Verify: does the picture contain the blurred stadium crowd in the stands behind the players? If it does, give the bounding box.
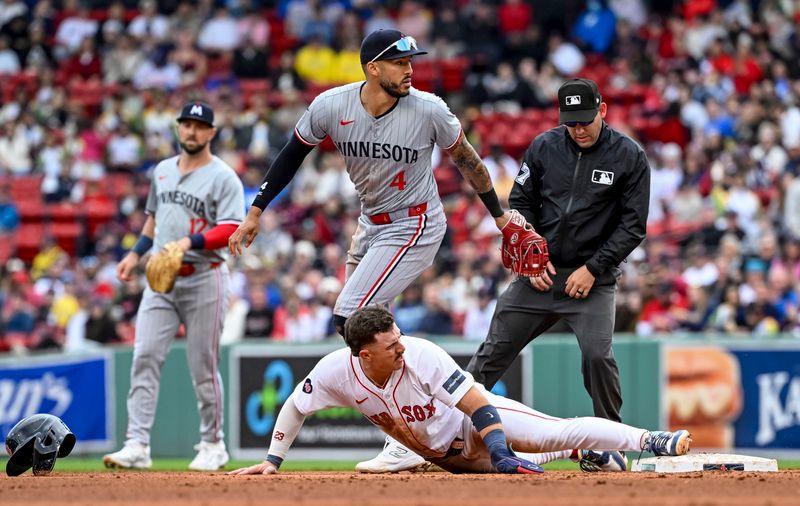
[0,0,800,352]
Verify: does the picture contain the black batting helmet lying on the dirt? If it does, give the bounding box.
[6,414,75,476]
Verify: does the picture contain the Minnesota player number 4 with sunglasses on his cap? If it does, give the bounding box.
[229,30,508,472]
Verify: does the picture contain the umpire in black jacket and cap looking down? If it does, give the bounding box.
[467,79,650,421]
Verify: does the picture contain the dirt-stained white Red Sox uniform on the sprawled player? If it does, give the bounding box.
[276,336,647,472]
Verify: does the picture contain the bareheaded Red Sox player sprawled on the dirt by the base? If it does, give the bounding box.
[229,306,692,474]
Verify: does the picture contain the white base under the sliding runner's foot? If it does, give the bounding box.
[631,453,778,473]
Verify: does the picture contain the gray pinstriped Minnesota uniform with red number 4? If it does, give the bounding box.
[295,82,461,317]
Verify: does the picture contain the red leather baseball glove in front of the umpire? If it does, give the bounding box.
[501,209,550,276]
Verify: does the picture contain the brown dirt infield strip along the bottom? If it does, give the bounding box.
[0,470,800,506]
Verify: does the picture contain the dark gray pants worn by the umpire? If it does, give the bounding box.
[467,267,622,422]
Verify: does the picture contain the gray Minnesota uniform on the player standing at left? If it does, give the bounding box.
[127,156,244,444]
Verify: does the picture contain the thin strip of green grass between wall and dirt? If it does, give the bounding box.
[0,457,800,472]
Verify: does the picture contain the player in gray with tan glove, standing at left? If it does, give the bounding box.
[103,102,244,471]
